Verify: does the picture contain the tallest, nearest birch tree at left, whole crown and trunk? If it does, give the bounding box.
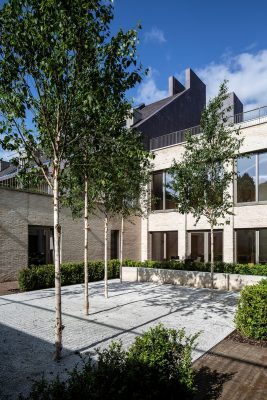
[0,0,122,360]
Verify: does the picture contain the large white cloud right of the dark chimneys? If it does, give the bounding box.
[196,50,267,109]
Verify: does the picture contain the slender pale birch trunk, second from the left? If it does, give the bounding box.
[84,176,89,315]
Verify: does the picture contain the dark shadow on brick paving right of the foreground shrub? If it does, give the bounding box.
[193,366,236,400]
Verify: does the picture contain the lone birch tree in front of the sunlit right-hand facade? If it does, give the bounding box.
[169,82,242,289]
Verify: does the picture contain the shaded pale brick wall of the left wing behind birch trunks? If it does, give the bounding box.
[0,188,141,282]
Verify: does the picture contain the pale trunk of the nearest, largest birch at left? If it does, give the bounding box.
[53,168,63,361]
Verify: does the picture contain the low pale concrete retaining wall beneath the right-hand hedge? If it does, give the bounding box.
[122,267,267,291]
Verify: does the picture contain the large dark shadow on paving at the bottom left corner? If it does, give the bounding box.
[0,324,86,400]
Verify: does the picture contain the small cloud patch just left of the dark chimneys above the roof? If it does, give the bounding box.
[134,68,168,104]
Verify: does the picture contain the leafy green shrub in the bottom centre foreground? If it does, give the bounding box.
[22,324,197,400]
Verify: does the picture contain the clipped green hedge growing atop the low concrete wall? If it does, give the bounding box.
[123,260,267,276]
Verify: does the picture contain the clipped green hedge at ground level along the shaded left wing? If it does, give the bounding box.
[18,260,120,291]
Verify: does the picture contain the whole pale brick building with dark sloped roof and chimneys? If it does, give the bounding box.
[0,69,267,281]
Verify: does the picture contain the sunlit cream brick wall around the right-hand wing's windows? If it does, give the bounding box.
[144,120,267,262]
